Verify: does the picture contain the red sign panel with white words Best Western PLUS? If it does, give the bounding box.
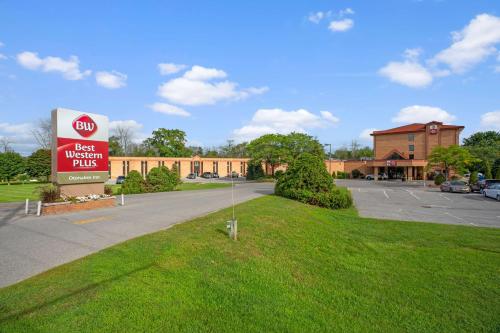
[57,138,108,172]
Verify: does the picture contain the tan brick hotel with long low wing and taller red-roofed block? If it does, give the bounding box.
[109,121,464,180]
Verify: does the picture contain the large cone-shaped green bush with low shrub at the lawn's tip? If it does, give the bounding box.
[275,153,352,209]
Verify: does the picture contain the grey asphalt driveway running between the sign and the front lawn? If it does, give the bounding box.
[0,183,274,287]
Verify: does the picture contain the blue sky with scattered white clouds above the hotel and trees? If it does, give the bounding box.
[0,0,500,153]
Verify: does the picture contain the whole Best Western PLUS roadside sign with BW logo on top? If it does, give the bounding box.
[52,108,108,184]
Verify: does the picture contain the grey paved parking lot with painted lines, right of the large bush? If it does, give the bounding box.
[337,180,500,228]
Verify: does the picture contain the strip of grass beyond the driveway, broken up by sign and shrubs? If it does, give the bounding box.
[0,183,231,202]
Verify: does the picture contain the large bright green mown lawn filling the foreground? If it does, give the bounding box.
[0,196,500,332]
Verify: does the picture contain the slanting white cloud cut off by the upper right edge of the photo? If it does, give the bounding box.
[431,14,500,73]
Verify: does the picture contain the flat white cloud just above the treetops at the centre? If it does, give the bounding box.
[233,109,339,141]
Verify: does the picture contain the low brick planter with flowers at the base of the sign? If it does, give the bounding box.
[42,194,116,215]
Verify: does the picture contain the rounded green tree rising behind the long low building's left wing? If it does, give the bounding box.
[144,128,191,157]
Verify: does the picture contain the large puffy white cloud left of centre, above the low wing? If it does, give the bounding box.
[158,66,268,105]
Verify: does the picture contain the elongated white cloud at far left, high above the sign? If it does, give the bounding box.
[17,52,91,80]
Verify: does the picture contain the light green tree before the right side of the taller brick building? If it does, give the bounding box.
[428,145,477,179]
